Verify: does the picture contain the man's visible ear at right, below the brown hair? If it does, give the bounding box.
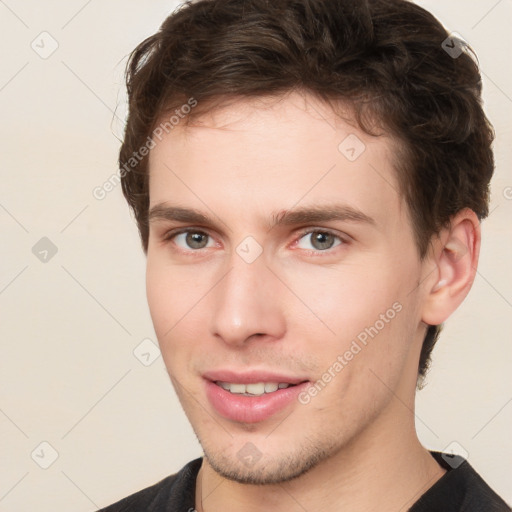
[422,208,481,325]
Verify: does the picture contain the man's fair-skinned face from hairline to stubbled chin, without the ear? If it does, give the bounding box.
[147,94,425,483]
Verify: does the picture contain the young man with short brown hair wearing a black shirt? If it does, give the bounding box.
[99,0,510,512]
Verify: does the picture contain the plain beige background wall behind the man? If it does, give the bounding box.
[0,0,512,512]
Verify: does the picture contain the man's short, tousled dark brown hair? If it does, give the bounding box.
[119,0,494,377]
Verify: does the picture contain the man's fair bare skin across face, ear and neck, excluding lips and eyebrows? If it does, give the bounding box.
[147,92,480,512]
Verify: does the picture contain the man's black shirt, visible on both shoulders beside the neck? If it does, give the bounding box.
[99,452,511,512]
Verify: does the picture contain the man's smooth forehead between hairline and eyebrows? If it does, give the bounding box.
[149,93,402,230]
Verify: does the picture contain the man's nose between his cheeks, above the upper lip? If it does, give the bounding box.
[211,252,285,347]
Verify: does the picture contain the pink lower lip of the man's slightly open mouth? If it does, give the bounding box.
[205,380,309,423]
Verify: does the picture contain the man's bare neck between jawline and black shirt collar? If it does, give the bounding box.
[196,400,445,512]
